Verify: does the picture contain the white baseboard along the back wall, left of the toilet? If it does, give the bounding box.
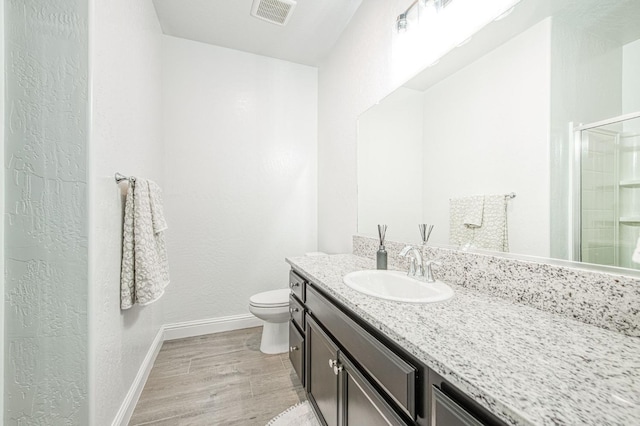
[164,314,262,340]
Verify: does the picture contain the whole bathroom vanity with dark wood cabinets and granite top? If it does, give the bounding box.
[287,255,640,426]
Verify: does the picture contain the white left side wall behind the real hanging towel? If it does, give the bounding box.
[89,0,165,425]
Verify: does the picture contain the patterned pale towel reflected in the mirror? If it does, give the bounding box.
[449,194,509,252]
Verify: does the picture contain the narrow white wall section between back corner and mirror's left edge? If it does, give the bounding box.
[318,0,404,253]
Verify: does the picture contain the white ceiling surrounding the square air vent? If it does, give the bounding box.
[153,0,362,66]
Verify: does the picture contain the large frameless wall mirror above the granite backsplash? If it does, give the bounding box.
[358,0,640,269]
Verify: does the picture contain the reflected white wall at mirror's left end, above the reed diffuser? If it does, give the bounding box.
[357,87,424,241]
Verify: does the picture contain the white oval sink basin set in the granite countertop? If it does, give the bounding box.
[342,270,453,303]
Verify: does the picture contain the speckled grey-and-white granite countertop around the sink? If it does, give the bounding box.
[287,254,640,426]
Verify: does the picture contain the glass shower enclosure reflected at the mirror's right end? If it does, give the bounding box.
[574,112,640,269]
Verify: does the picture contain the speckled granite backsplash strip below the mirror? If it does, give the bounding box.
[353,235,640,338]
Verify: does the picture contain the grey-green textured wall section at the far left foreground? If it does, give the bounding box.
[4,0,88,424]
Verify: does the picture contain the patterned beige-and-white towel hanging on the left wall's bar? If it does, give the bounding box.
[120,179,169,309]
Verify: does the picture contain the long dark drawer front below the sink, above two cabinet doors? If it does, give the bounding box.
[306,286,416,419]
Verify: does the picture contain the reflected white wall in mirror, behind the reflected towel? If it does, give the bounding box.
[423,19,551,257]
